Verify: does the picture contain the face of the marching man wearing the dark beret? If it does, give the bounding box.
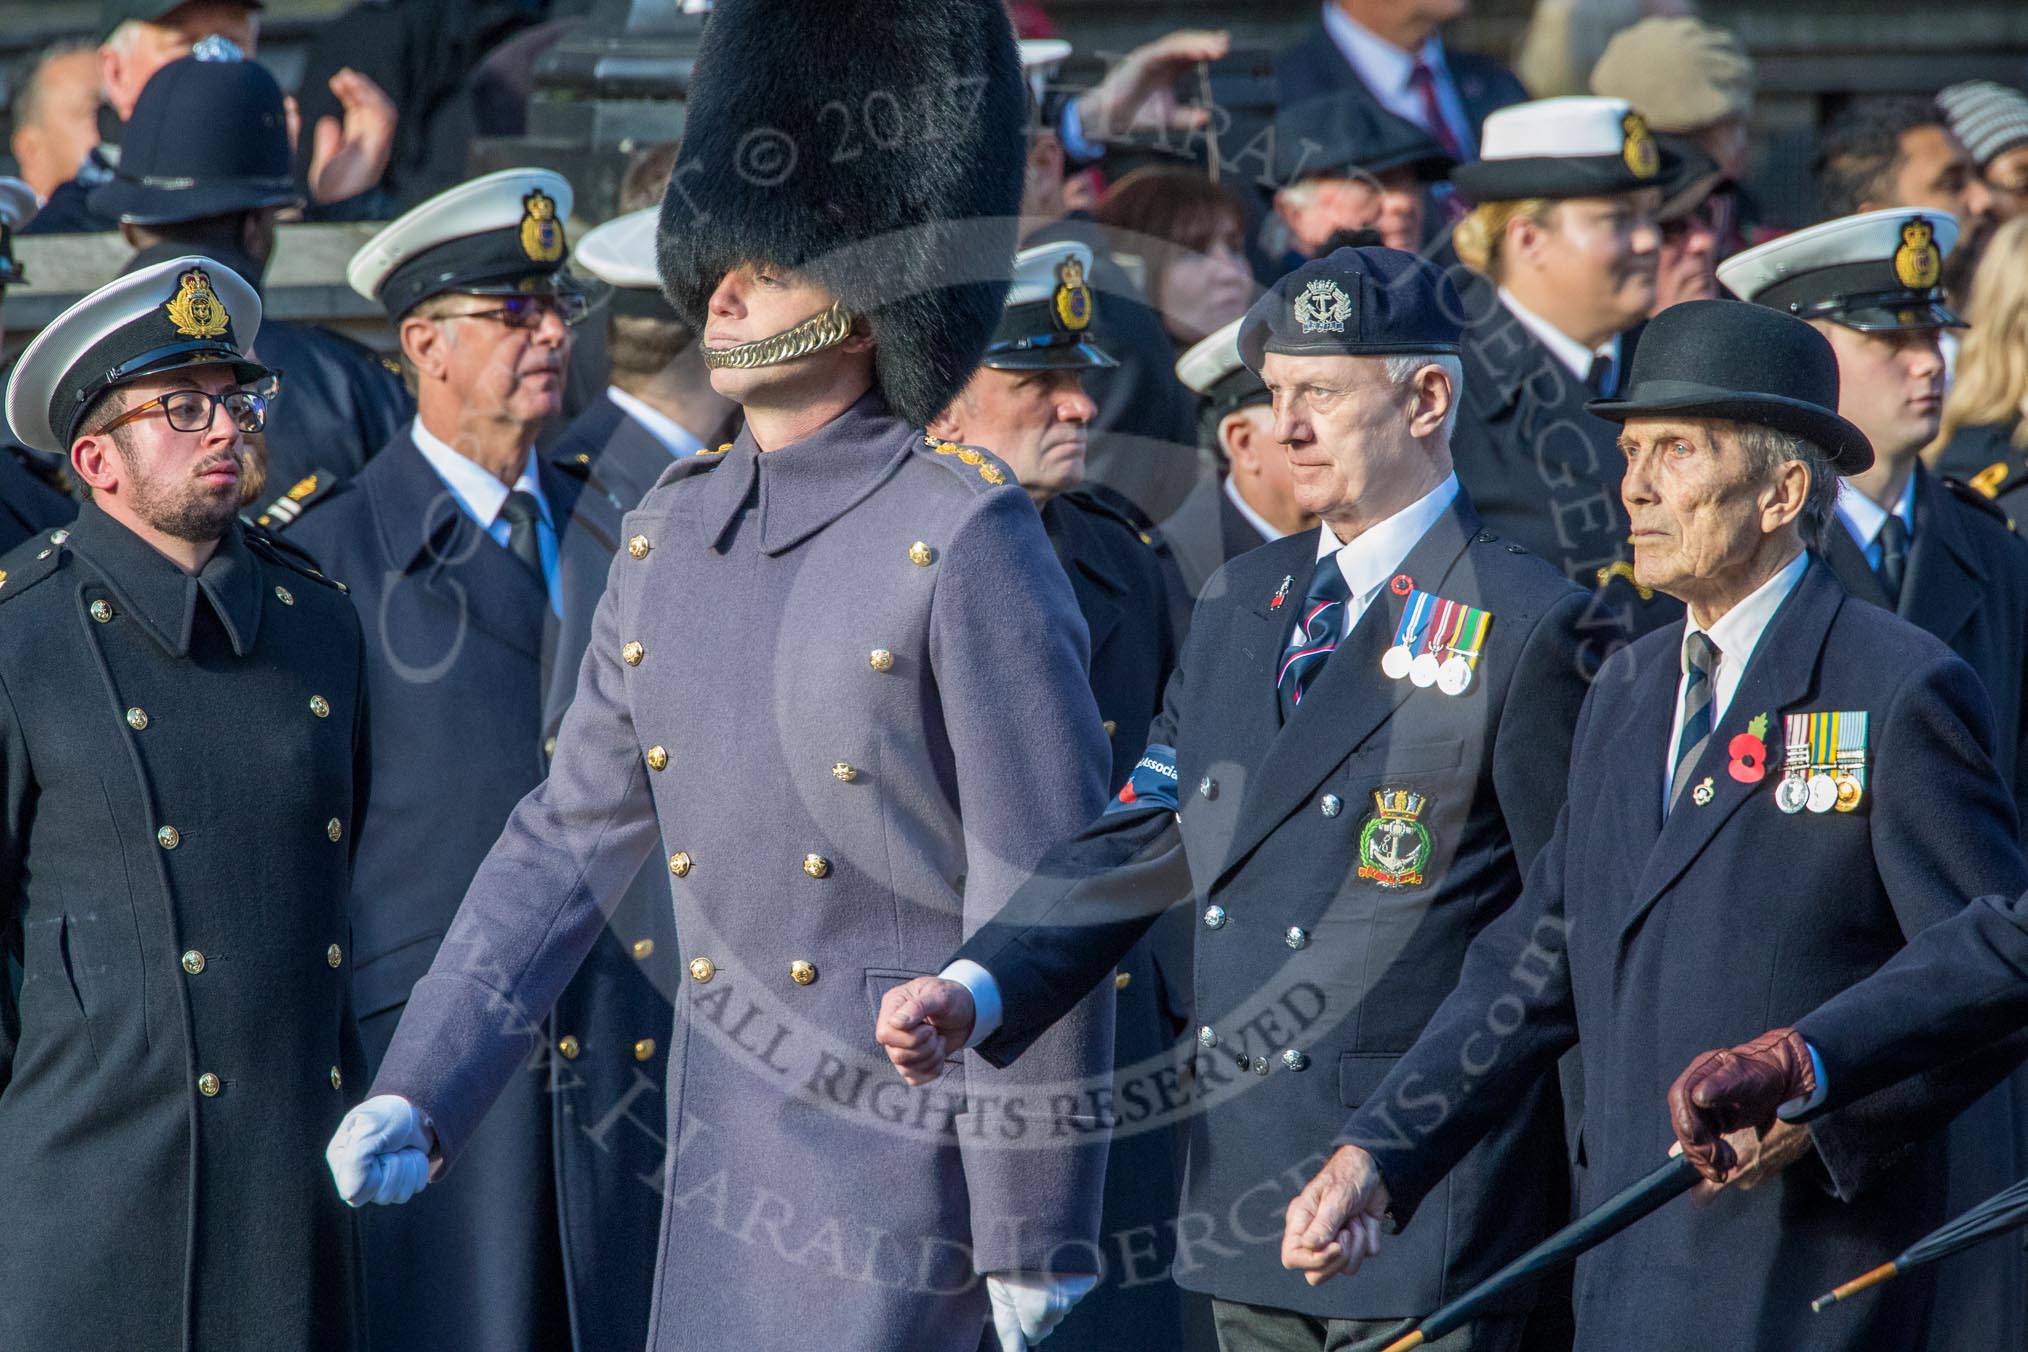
[1261,353,1442,517]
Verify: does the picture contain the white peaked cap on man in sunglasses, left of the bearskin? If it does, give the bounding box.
[345,168,574,318]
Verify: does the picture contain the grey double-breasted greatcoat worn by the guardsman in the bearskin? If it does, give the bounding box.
[375,393,1113,1352]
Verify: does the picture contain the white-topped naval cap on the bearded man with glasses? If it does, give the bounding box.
[6,253,268,456]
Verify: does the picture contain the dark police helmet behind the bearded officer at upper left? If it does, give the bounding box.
[89,39,302,225]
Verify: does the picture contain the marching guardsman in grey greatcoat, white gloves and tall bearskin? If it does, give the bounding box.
[327,0,1115,1352]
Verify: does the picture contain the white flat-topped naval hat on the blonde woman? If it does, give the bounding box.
[1450,93,1665,203]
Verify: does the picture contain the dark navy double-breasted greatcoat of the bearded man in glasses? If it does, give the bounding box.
[0,505,367,1352]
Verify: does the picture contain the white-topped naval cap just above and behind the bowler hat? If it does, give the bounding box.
[1718,207,1963,332]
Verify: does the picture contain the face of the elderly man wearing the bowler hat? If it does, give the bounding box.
[1620,418,1809,606]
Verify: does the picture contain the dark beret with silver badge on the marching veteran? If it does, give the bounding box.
[1239,245,1464,373]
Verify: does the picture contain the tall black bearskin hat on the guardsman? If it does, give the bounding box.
[657,0,1028,424]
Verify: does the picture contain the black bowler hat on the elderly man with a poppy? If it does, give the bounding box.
[1584,300,1874,474]
